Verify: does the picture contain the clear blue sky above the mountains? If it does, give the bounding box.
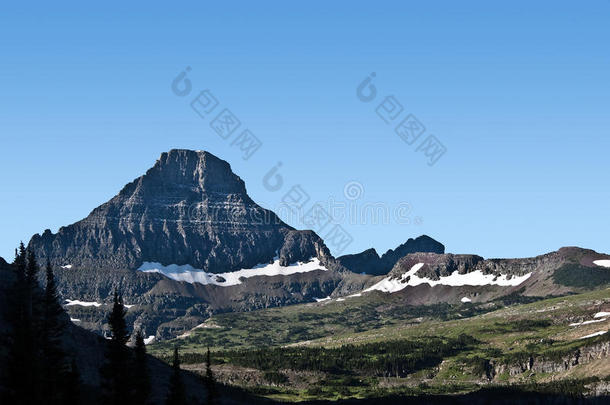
[0,1,610,259]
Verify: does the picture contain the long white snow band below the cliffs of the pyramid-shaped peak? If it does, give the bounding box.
[138,258,328,287]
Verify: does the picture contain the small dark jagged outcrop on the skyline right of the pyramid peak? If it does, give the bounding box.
[337,235,445,276]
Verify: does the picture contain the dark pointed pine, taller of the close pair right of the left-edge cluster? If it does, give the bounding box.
[100,291,131,405]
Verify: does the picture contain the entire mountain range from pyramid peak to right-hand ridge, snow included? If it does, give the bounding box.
[15,149,608,342]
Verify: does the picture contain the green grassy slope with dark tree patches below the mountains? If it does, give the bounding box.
[150,289,610,401]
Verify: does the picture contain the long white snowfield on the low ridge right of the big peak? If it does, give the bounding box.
[364,263,532,293]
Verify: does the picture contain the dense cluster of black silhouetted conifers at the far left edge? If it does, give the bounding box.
[3,243,80,405]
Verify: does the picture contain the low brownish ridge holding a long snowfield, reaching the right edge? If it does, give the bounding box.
[356,243,610,305]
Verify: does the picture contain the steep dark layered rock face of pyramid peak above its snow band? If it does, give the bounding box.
[29,149,331,272]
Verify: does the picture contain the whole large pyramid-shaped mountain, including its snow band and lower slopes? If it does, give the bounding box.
[21,149,356,338]
